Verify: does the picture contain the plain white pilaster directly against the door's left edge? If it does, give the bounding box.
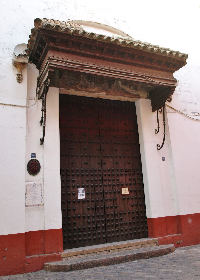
[44,88,62,230]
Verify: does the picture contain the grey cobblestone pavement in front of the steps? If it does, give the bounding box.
[0,245,200,280]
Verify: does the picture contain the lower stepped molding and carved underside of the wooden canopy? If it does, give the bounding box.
[37,54,177,107]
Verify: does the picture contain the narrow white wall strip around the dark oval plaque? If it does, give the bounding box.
[25,64,45,232]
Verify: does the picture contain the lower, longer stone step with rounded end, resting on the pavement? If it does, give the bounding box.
[44,244,175,272]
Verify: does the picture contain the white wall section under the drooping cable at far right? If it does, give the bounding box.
[167,112,200,215]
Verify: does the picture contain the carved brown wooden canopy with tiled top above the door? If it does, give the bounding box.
[27,19,187,111]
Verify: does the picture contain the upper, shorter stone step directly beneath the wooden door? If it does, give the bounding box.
[61,238,158,258]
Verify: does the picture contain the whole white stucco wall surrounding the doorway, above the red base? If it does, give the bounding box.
[0,0,200,234]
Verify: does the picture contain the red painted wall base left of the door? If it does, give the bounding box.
[0,229,63,276]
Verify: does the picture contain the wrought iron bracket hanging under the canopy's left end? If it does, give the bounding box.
[40,79,50,145]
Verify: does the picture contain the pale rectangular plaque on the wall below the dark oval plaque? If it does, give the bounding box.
[25,182,43,206]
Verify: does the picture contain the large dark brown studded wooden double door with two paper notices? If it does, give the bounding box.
[60,95,148,248]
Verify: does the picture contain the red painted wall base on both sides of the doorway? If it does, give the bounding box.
[0,213,200,275]
